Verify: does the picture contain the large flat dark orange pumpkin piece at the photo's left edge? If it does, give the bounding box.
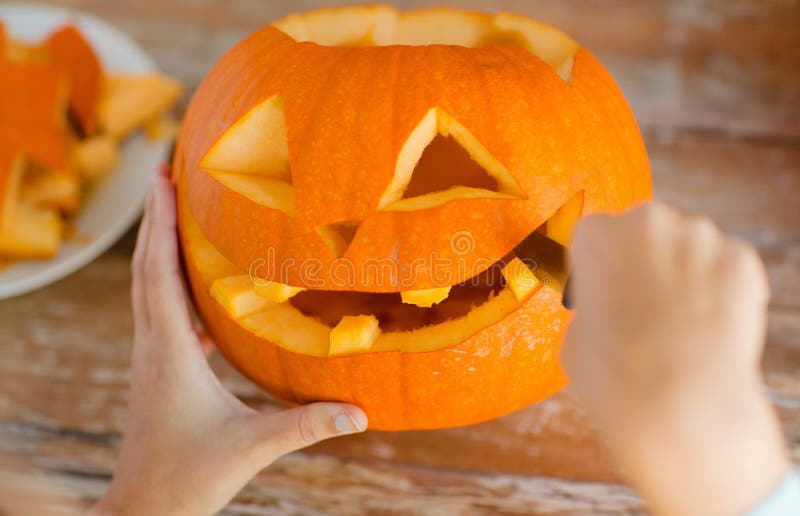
[0,62,68,169]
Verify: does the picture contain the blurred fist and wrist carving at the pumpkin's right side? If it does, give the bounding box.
[562,204,787,516]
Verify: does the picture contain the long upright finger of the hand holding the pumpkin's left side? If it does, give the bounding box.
[144,176,193,341]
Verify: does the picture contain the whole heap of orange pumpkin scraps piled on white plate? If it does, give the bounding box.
[0,23,182,263]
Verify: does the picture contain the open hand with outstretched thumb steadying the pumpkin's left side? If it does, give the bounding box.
[93,169,367,515]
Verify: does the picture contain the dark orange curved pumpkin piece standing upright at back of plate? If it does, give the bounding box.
[45,25,103,135]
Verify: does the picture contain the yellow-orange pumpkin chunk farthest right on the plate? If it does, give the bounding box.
[97,74,183,139]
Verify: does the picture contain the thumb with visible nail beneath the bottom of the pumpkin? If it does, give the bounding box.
[250,403,367,460]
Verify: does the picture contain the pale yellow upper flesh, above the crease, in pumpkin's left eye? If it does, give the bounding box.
[200,95,291,182]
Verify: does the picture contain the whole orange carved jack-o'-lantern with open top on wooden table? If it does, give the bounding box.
[175,7,651,429]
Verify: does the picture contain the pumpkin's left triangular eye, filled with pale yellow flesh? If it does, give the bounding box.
[200,95,294,215]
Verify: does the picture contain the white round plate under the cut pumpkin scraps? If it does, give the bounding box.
[0,4,169,299]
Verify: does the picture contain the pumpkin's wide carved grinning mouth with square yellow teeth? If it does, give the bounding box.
[180,186,583,356]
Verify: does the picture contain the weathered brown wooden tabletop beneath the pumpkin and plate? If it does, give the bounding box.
[0,0,800,515]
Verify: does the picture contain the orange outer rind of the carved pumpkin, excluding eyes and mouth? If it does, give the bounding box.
[173,6,652,430]
